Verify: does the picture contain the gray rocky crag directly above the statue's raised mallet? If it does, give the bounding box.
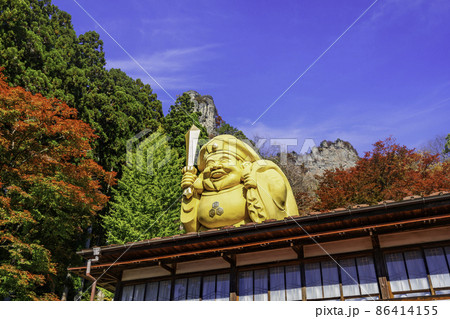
[186,90,217,135]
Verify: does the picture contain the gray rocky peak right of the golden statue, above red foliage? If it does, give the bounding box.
[297,139,359,175]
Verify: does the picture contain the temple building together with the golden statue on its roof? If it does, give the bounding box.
[71,131,450,301]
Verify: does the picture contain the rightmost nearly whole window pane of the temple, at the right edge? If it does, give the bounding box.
[425,247,450,288]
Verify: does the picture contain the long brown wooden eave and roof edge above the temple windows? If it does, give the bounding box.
[69,193,450,290]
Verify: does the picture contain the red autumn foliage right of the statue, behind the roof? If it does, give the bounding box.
[315,138,450,210]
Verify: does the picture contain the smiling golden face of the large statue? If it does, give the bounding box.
[203,153,242,191]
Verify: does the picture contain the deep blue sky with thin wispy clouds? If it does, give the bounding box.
[53,0,450,155]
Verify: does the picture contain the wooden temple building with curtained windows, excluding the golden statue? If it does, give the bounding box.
[70,192,450,301]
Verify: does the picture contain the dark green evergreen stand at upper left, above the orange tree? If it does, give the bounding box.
[0,0,163,176]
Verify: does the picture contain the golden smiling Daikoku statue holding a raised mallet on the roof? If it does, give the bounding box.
[181,126,298,232]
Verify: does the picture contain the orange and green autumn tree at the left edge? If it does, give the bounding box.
[0,73,114,300]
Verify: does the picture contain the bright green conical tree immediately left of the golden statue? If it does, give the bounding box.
[103,129,183,244]
